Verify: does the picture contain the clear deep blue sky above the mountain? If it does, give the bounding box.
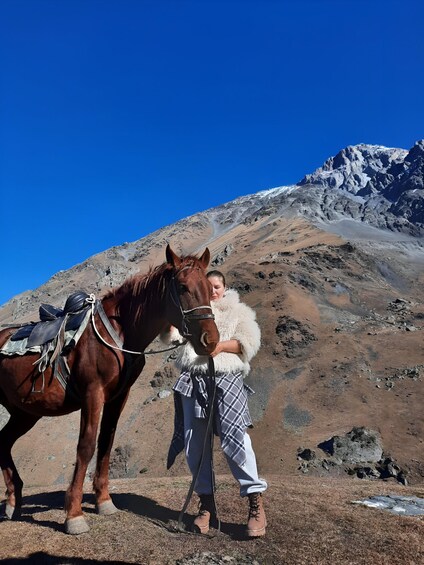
[0,0,424,304]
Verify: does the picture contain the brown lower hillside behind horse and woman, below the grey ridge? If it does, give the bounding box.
[3,219,424,485]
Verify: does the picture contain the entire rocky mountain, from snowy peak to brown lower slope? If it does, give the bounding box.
[0,141,424,494]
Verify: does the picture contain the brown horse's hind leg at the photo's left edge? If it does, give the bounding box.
[0,410,40,520]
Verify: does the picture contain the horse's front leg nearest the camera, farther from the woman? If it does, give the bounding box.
[65,391,103,534]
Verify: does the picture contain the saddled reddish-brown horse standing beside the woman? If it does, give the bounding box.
[0,245,219,534]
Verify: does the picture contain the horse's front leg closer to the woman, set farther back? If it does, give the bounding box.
[93,391,129,515]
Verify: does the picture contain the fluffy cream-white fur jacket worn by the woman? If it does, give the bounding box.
[162,289,261,375]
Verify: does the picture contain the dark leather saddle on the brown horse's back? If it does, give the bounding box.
[10,291,90,347]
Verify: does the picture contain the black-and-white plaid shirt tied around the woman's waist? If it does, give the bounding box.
[167,371,254,469]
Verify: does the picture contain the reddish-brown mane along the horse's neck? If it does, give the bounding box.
[104,255,198,322]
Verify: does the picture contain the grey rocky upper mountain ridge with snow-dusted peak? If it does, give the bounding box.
[0,140,424,322]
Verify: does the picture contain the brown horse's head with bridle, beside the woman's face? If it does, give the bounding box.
[166,245,219,355]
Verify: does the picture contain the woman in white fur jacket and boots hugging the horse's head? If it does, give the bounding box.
[167,271,267,537]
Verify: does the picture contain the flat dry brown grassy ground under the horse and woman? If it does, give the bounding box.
[0,476,424,565]
